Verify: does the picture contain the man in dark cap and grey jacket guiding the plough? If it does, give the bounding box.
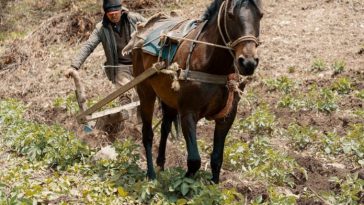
[66,0,145,104]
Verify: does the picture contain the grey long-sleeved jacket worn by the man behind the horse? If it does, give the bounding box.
[71,10,145,70]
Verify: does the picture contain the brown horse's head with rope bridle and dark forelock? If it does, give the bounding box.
[219,0,263,75]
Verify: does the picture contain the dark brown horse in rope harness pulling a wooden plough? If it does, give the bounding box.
[133,0,263,183]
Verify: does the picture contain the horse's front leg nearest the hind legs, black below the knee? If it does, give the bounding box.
[181,112,201,177]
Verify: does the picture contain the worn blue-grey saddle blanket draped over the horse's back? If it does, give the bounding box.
[143,19,197,63]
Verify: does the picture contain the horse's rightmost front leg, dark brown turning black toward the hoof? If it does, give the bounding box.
[210,97,237,184]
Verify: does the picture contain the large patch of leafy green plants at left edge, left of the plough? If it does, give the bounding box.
[0,100,90,169]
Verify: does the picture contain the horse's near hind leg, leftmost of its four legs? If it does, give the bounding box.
[137,84,156,180]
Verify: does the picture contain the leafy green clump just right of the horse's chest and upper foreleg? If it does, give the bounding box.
[239,105,276,134]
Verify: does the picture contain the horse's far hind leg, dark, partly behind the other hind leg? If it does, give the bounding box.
[157,102,177,170]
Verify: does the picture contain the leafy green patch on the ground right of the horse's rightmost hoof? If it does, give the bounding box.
[224,138,305,186]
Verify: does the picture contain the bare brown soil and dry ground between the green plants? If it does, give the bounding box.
[0,0,364,204]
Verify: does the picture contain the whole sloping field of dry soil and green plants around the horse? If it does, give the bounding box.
[0,0,364,205]
